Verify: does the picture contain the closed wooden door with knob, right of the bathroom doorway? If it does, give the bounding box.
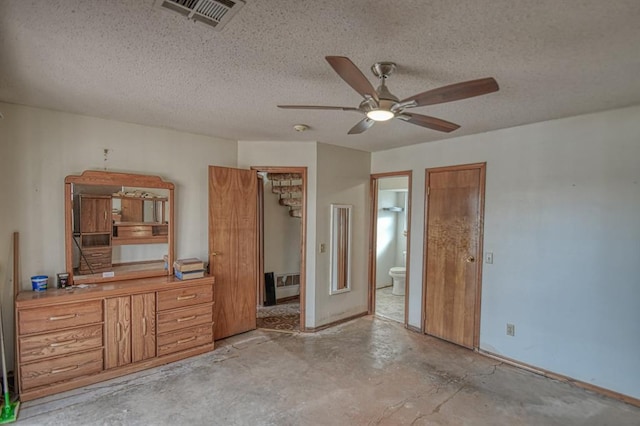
[424,163,485,348]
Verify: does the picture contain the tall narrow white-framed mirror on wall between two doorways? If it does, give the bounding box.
[329,204,353,294]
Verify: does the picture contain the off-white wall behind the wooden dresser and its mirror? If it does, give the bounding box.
[0,103,236,370]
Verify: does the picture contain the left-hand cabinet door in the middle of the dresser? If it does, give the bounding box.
[104,296,131,369]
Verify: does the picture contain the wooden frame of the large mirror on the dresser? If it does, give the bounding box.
[64,170,175,284]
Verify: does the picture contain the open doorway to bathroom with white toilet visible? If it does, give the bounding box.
[369,171,411,325]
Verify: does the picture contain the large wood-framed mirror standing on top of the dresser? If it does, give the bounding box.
[65,171,174,284]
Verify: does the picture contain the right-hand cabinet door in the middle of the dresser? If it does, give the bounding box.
[131,293,156,362]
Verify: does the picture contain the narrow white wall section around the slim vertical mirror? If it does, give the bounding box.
[315,143,371,326]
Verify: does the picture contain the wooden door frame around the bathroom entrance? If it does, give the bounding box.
[367,170,413,327]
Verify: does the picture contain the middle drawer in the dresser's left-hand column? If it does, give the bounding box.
[20,324,102,362]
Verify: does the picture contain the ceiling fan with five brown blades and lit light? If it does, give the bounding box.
[278,56,499,135]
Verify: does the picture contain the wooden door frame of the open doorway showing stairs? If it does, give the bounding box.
[251,166,308,331]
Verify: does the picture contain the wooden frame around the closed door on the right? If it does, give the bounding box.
[420,162,487,351]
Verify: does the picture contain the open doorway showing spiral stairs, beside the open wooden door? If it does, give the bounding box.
[253,167,306,332]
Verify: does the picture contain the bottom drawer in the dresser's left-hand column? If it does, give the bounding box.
[20,349,102,390]
